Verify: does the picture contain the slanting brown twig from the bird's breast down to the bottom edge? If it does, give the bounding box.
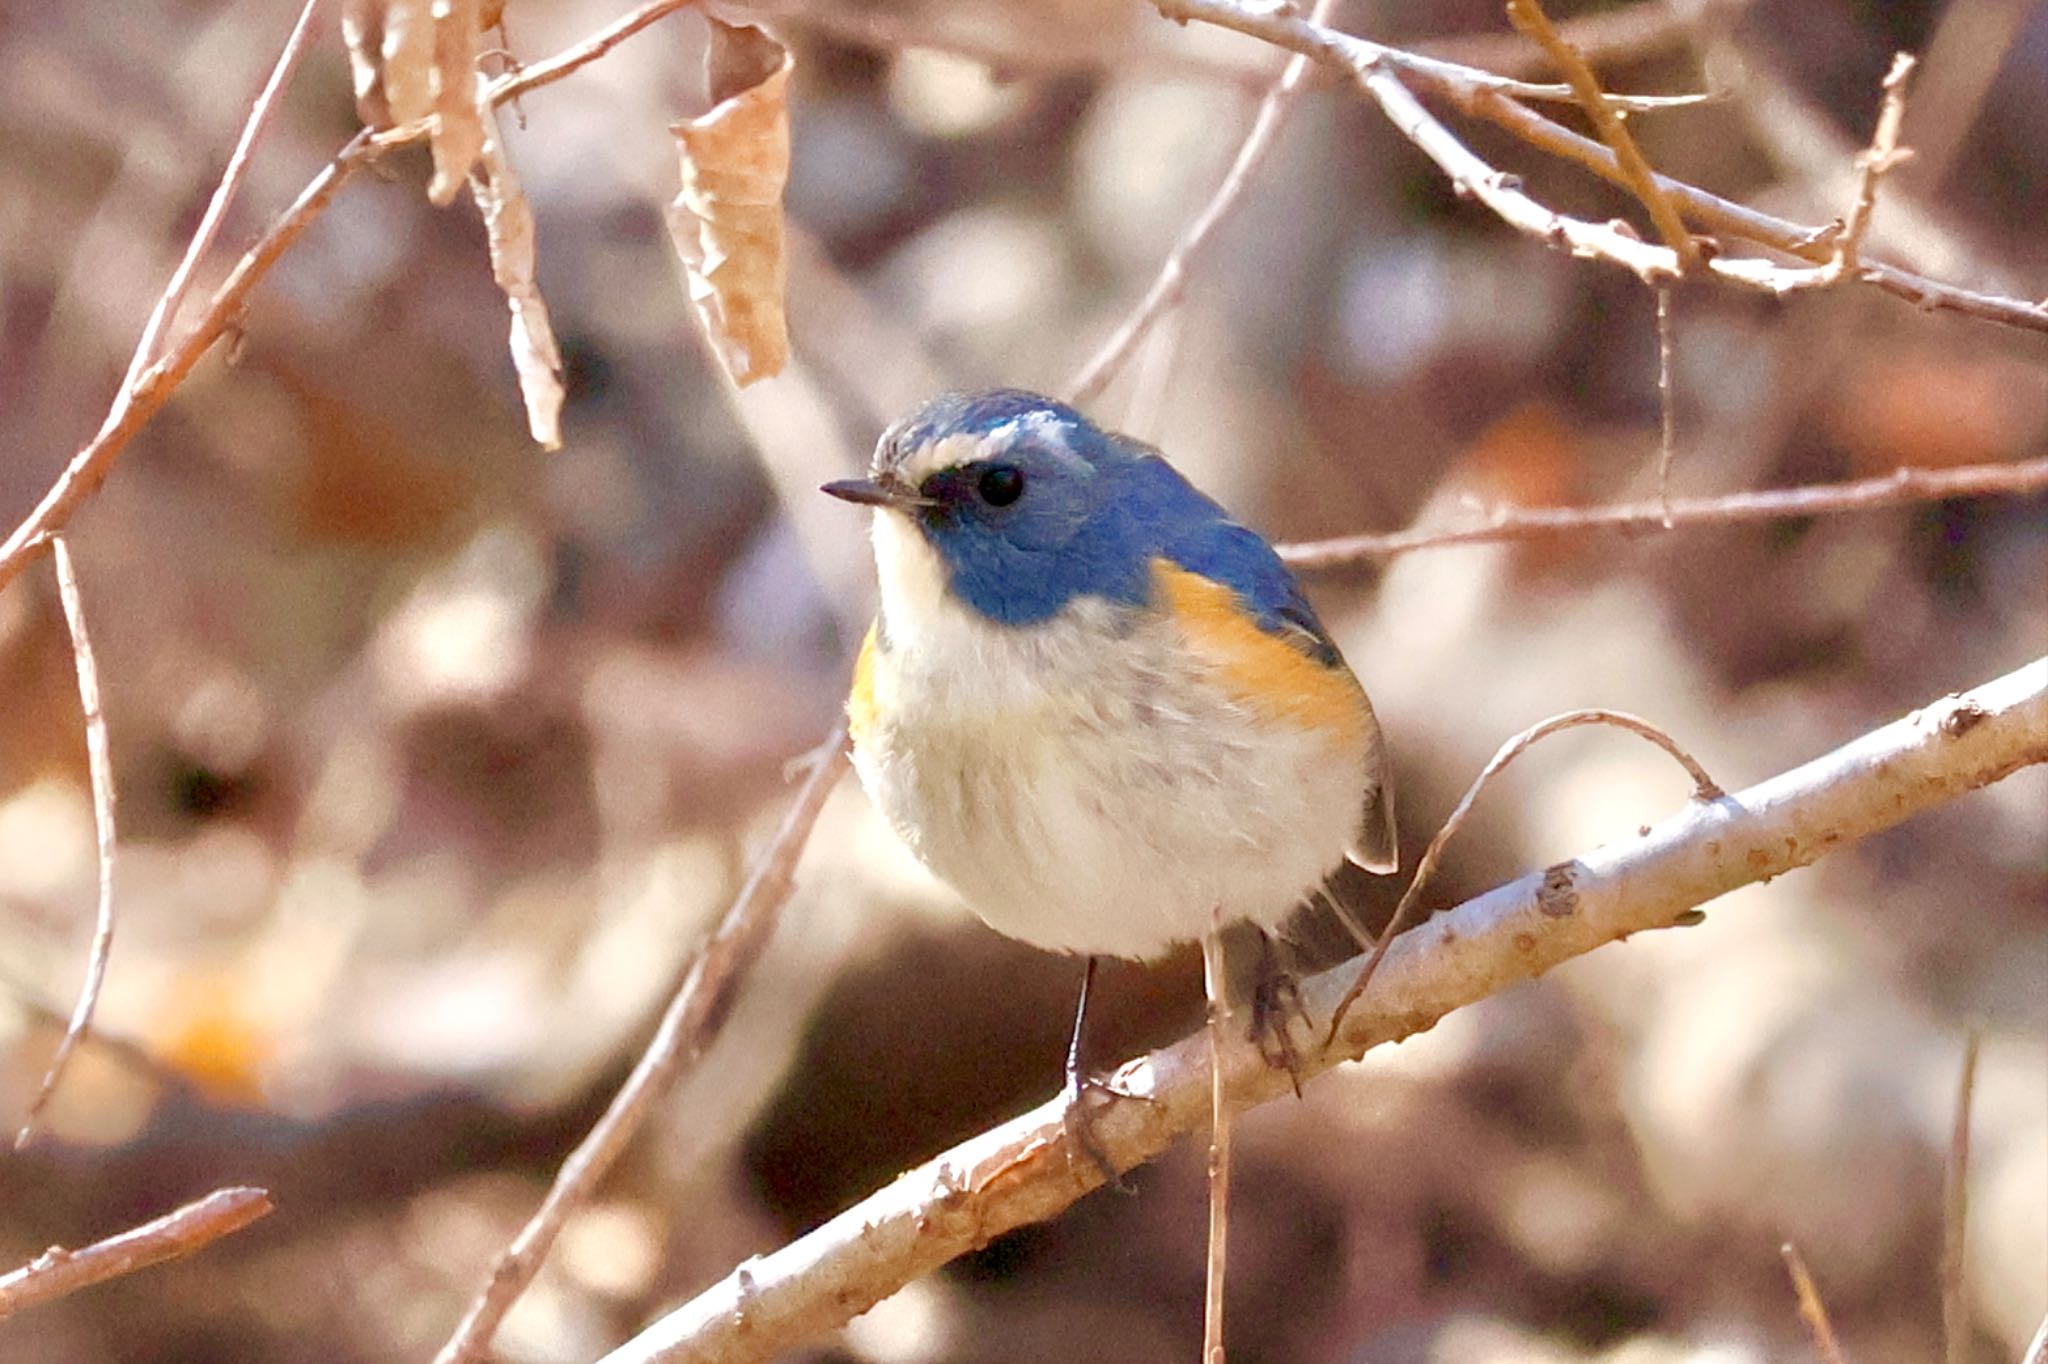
[434,721,846,1364]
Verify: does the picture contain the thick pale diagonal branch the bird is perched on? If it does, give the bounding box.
[606,659,2048,1364]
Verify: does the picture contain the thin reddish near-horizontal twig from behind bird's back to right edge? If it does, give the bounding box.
[1278,457,2048,571]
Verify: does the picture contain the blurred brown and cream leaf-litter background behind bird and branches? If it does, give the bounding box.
[0,0,2048,1364]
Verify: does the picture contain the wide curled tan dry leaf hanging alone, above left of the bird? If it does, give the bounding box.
[668,18,791,385]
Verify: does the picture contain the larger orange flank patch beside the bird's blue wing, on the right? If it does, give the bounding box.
[1153,559,1368,743]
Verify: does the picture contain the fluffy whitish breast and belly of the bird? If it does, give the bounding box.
[854,598,1366,956]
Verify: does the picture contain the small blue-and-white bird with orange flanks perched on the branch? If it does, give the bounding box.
[823,389,1399,1138]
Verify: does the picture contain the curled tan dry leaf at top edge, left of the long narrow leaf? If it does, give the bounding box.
[342,0,502,205]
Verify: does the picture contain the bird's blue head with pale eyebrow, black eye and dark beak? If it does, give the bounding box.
[825,389,1228,625]
